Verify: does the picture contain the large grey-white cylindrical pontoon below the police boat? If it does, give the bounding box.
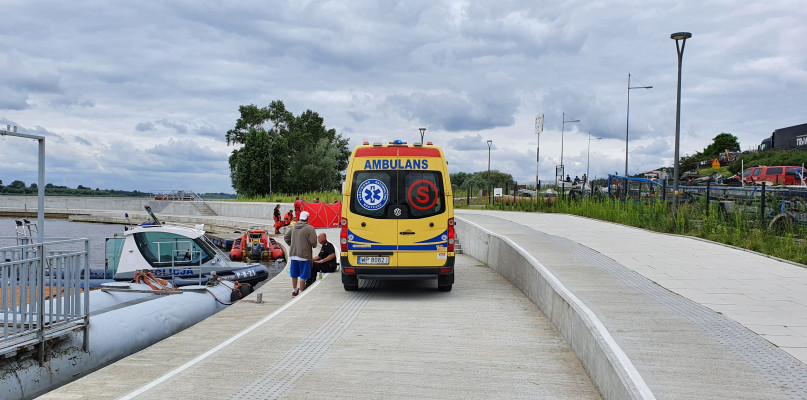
[0,283,233,399]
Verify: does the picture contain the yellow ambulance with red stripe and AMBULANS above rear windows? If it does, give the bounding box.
[339,140,455,292]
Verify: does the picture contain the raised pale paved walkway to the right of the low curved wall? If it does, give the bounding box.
[456,210,807,399]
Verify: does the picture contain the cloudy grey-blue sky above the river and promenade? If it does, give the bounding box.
[0,0,807,193]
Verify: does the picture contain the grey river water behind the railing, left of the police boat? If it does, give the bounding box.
[0,215,123,268]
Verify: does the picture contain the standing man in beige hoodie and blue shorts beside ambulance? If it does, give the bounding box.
[283,211,317,297]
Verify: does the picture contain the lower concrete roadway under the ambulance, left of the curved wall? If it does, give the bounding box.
[41,250,600,400]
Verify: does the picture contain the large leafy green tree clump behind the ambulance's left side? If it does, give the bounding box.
[226,100,350,196]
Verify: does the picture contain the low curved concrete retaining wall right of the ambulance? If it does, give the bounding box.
[457,217,655,400]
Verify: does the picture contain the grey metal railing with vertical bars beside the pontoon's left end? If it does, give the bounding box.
[0,237,90,361]
